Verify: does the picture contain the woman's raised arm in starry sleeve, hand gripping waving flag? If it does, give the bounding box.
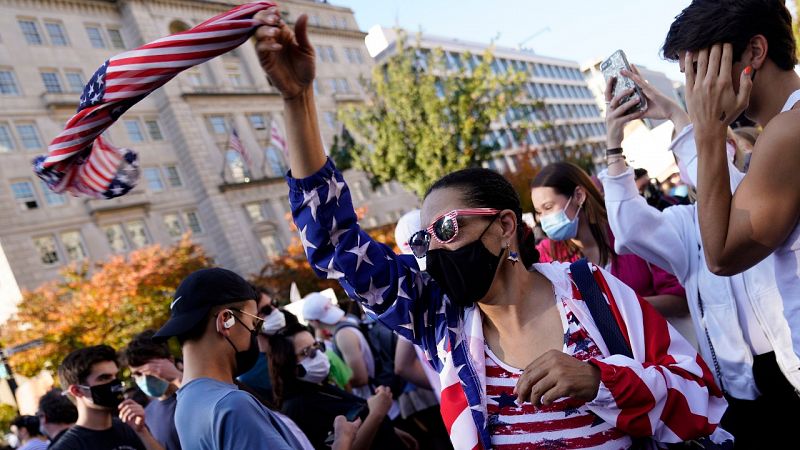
[255,8,446,353]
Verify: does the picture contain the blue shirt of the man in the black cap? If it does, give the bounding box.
[175,378,302,450]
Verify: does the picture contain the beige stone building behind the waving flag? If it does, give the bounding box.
[0,0,418,310]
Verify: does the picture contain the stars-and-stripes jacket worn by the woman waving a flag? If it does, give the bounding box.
[287,160,730,450]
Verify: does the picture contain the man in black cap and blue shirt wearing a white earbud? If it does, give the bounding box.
[153,268,357,450]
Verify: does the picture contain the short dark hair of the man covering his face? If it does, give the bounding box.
[662,0,797,70]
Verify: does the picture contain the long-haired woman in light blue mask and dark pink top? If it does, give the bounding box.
[531,162,696,346]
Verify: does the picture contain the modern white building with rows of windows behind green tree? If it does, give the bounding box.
[367,26,606,172]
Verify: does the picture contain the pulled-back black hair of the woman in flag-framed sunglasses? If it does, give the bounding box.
[425,168,539,267]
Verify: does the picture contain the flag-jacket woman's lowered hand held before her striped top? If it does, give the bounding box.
[514,350,600,406]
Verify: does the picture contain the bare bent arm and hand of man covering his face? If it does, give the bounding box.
[685,44,800,276]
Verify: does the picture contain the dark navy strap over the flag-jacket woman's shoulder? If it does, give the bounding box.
[569,258,633,358]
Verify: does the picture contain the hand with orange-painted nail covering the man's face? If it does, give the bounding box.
[684,44,753,139]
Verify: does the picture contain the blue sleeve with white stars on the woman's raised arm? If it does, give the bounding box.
[287,160,446,353]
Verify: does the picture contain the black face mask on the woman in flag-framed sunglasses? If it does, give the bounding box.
[427,220,503,307]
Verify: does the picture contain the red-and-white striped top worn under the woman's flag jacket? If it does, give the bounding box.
[486,300,632,450]
